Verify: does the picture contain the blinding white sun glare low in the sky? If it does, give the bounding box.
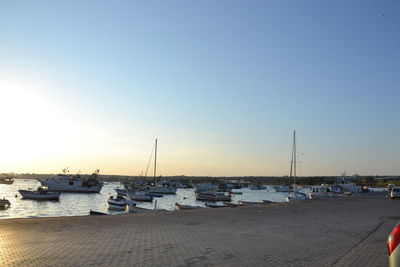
[0,79,63,171]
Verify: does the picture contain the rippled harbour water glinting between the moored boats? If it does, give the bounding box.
[0,179,294,219]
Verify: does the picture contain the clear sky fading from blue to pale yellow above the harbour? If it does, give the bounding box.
[0,0,400,176]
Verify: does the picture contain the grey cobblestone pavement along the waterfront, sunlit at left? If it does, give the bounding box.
[0,193,400,266]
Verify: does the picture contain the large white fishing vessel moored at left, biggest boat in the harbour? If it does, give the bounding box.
[40,168,103,193]
